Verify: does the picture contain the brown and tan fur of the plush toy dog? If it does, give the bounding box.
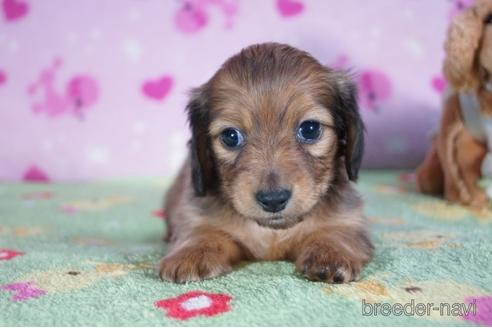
[417,0,492,207]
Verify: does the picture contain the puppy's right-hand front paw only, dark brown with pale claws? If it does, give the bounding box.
[296,246,363,284]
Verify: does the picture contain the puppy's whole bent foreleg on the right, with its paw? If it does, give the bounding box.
[296,227,374,283]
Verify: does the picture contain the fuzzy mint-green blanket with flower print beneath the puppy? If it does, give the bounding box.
[0,172,492,326]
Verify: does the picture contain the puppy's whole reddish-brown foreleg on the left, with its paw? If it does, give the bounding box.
[157,228,242,283]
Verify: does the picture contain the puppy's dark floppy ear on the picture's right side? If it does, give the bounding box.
[333,72,365,181]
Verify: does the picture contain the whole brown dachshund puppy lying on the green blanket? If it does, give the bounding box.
[158,43,373,283]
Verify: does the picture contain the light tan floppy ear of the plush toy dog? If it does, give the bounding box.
[443,7,483,90]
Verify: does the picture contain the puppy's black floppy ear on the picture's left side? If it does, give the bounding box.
[186,87,217,197]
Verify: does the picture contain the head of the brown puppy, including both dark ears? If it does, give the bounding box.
[187,43,364,228]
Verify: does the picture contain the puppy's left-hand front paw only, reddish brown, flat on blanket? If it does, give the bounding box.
[157,247,231,283]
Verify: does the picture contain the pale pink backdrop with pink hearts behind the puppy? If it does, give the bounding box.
[0,0,469,180]
